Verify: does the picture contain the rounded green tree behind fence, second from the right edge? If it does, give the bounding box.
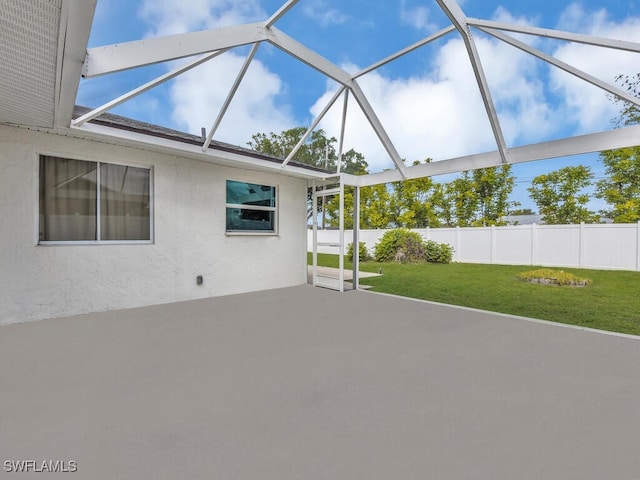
[527,165,598,225]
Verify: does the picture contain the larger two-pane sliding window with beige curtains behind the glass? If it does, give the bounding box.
[39,156,151,243]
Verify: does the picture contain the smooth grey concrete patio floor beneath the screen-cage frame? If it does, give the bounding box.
[0,286,640,480]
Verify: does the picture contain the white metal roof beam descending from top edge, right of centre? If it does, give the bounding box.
[436,0,508,163]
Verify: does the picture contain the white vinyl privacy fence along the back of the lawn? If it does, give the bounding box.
[307,222,640,271]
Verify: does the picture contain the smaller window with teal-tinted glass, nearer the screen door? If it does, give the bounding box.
[227,180,277,233]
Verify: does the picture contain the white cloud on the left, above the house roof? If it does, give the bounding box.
[140,0,296,146]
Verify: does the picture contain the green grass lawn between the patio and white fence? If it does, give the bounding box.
[309,255,640,335]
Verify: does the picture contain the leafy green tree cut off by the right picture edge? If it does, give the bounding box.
[596,74,640,223]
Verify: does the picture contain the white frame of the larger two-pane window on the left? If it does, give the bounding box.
[36,152,155,246]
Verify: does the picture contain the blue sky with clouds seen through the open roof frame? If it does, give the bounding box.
[78,0,640,208]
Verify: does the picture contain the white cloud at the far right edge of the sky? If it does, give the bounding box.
[551,4,640,133]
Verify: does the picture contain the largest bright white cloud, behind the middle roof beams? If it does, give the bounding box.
[311,29,554,171]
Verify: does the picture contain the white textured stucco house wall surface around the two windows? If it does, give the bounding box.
[0,115,328,323]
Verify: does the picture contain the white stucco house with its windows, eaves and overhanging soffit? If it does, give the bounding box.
[0,0,326,324]
